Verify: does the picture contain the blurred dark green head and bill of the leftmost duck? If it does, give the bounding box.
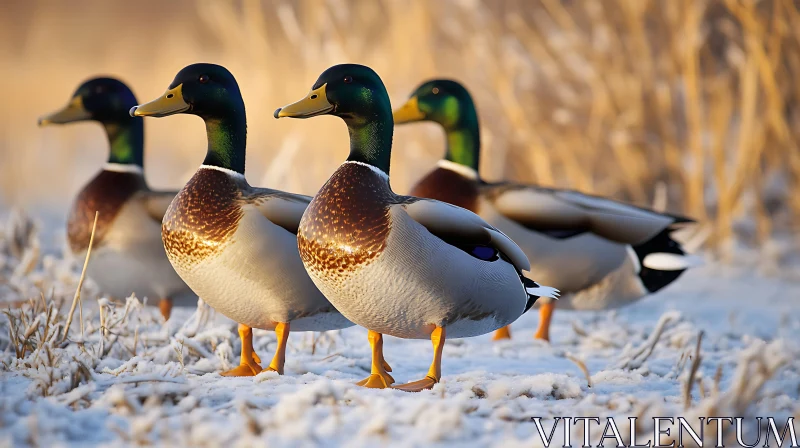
[39,78,144,166]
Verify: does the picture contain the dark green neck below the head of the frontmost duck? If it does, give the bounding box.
[345,111,394,176]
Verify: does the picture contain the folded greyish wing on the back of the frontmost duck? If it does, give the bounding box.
[403,198,531,271]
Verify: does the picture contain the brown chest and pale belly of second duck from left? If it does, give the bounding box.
[163,169,351,331]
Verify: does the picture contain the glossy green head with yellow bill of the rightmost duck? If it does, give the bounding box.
[394,79,481,171]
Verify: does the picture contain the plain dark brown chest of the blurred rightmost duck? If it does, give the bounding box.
[410,168,478,213]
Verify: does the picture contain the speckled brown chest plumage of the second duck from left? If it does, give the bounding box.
[161,169,242,267]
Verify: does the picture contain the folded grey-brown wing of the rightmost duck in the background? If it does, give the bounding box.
[491,186,693,245]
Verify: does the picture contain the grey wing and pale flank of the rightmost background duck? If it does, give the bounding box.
[478,183,682,310]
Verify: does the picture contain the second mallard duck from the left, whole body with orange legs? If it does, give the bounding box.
[130,64,353,376]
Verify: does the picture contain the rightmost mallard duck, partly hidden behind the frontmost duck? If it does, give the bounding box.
[394,79,698,340]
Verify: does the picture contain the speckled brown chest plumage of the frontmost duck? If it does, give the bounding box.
[297,163,396,276]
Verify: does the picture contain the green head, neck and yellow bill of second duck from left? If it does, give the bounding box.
[130,64,247,174]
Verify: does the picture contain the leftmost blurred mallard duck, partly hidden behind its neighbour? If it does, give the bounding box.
[39,78,189,319]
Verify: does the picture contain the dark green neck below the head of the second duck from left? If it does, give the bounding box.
[203,104,247,174]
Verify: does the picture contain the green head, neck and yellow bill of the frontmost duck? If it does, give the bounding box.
[275,64,394,174]
